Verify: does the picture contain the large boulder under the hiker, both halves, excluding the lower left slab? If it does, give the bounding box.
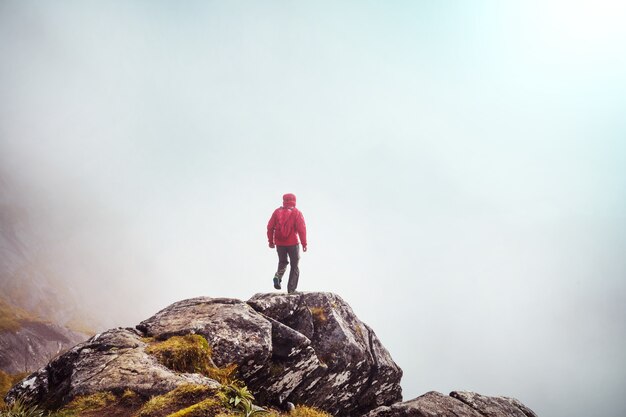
[137,293,402,415]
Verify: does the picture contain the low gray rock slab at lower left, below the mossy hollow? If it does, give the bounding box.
[6,329,219,408]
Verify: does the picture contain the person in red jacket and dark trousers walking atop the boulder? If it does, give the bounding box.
[267,194,306,294]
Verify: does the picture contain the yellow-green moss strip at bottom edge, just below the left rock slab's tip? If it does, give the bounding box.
[138,384,215,417]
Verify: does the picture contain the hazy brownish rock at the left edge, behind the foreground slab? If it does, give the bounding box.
[0,320,88,374]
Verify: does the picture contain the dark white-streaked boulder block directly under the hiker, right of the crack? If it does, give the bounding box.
[247,293,402,415]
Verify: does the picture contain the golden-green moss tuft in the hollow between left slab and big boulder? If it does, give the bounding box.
[146,334,237,384]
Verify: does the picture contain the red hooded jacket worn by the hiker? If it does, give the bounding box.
[267,194,307,246]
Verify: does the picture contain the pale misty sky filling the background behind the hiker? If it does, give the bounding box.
[0,0,626,417]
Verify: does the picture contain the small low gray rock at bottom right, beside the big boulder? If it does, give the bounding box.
[363,391,537,417]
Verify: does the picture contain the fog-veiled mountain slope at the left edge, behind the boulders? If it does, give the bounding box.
[0,174,93,373]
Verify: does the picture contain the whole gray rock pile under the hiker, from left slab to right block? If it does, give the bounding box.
[9,293,402,415]
